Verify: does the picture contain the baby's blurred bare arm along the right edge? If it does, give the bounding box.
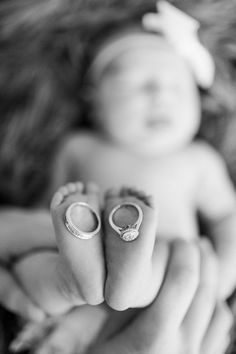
[197,144,236,298]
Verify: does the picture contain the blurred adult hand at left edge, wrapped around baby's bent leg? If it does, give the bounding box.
[0,209,56,321]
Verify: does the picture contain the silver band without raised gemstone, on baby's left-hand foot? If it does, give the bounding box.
[65,202,101,240]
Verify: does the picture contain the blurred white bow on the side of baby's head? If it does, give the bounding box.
[143,0,215,89]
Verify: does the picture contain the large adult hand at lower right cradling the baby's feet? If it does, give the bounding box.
[24,240,232,354]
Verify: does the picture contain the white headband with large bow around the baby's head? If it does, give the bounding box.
[91,0,215,89]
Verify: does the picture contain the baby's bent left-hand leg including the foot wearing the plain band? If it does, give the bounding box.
[14,183,105,315]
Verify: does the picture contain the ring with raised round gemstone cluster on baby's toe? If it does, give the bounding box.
[109,202,143,242]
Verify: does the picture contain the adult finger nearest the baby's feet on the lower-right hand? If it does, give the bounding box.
[90,240,200,354]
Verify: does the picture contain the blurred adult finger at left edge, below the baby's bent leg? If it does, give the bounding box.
[0,267,45,321]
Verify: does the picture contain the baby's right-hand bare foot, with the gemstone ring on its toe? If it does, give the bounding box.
[104,188,157,311]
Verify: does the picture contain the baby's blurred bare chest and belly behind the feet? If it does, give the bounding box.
[77,148,198,238]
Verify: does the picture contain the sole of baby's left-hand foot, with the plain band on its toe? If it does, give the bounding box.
[51,182,105,305]
